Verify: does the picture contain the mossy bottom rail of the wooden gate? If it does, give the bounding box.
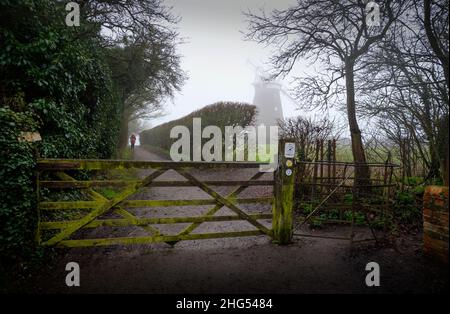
[56,230,264,247]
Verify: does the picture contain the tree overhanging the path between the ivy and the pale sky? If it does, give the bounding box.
[74,0,186,149]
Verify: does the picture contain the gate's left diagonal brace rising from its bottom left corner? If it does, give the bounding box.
[43,170,165,246]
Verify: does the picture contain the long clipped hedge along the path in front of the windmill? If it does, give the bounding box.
[140,102,256,157]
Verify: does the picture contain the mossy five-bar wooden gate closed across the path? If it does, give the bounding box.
[37,148,293,247]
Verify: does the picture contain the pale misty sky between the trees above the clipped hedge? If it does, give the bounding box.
[151,0,334,126]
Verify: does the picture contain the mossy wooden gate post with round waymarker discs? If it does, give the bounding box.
[272,139,296,244]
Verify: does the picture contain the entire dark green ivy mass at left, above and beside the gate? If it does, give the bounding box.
[0,0,122,270]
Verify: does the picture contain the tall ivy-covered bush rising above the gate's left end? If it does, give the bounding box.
[0,0,121,158]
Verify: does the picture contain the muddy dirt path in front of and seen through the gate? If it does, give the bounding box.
[31,147,448,293]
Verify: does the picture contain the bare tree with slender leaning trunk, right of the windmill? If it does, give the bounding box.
[247,0,403,184]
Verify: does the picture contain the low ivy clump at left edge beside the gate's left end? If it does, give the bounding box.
[0,107,37,262]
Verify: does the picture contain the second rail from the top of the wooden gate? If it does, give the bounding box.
[40,180,274,189]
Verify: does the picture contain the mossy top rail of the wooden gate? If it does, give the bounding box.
[37,159,269,170]
